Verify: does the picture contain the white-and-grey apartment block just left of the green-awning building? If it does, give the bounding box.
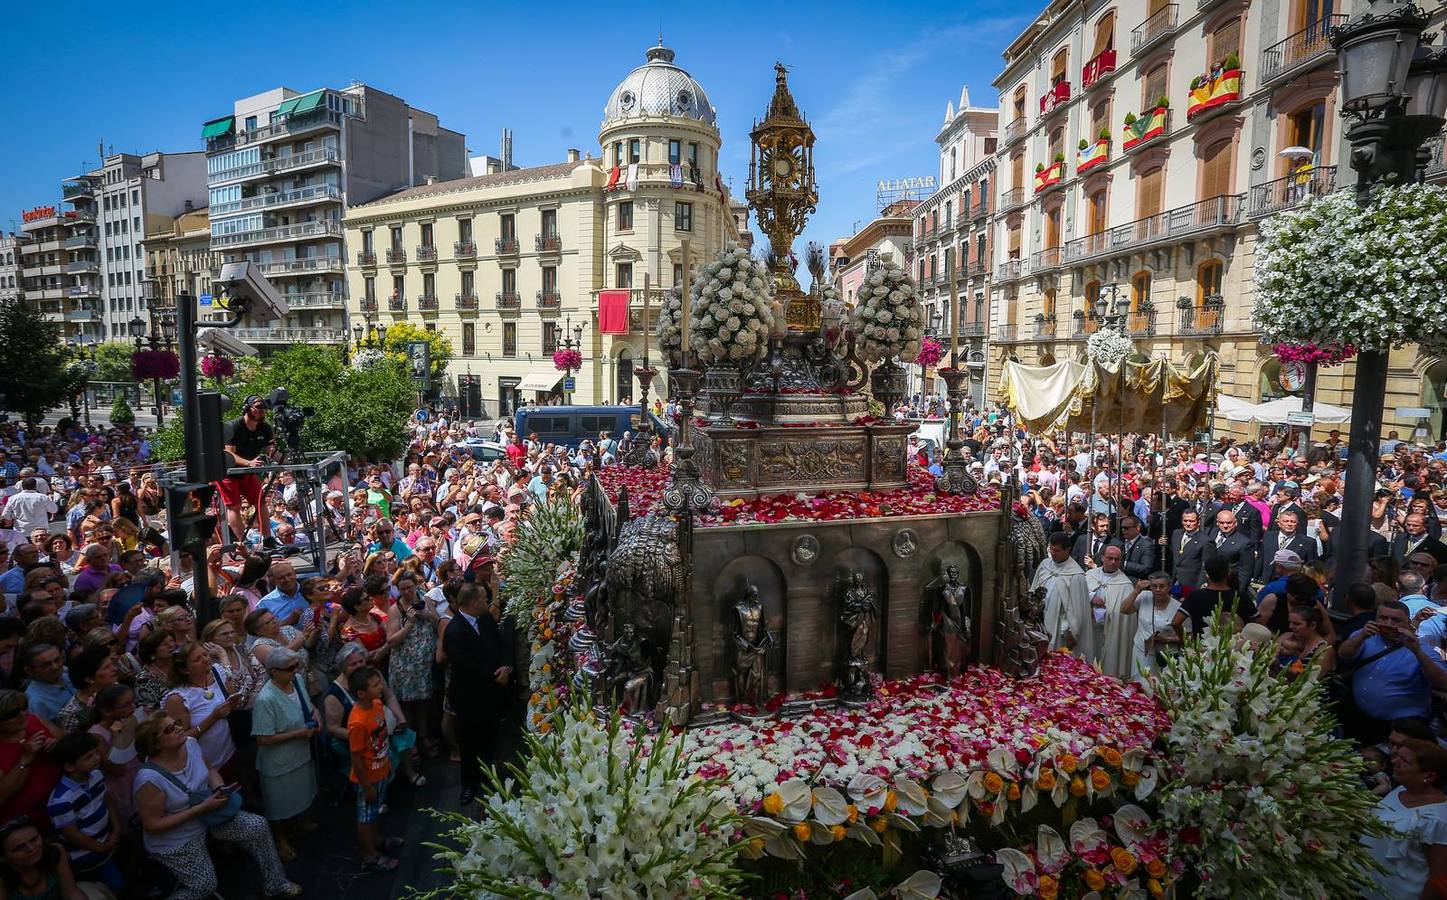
[61,150,205,340]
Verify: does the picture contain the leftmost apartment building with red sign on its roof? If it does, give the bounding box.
[19,204,94,344]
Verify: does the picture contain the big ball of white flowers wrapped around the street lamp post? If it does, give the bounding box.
[1253,184,1447,355]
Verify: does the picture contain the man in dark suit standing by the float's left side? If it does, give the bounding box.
[443,583,512,806]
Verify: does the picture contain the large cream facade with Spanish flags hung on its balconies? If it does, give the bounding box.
[990,0,1447,433]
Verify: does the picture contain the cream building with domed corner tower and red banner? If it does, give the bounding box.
[346,46,747,415]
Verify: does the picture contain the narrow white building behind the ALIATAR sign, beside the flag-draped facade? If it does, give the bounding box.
[912,87,1000,405]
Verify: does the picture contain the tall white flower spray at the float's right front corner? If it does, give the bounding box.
[1155,610,1380,897]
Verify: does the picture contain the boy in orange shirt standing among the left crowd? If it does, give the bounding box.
[347,666,402,873]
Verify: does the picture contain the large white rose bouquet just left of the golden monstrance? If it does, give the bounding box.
[689,243,774,363]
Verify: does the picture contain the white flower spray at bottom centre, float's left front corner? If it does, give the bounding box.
[430,700,744,900]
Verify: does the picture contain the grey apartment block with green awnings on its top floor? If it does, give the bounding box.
[198,84,467,350]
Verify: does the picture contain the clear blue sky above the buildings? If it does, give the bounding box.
[0,0,1033,274]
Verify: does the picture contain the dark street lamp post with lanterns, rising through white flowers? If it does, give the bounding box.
[1331,3,1447,609]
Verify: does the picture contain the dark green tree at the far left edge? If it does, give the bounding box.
[0,302,87,425]
